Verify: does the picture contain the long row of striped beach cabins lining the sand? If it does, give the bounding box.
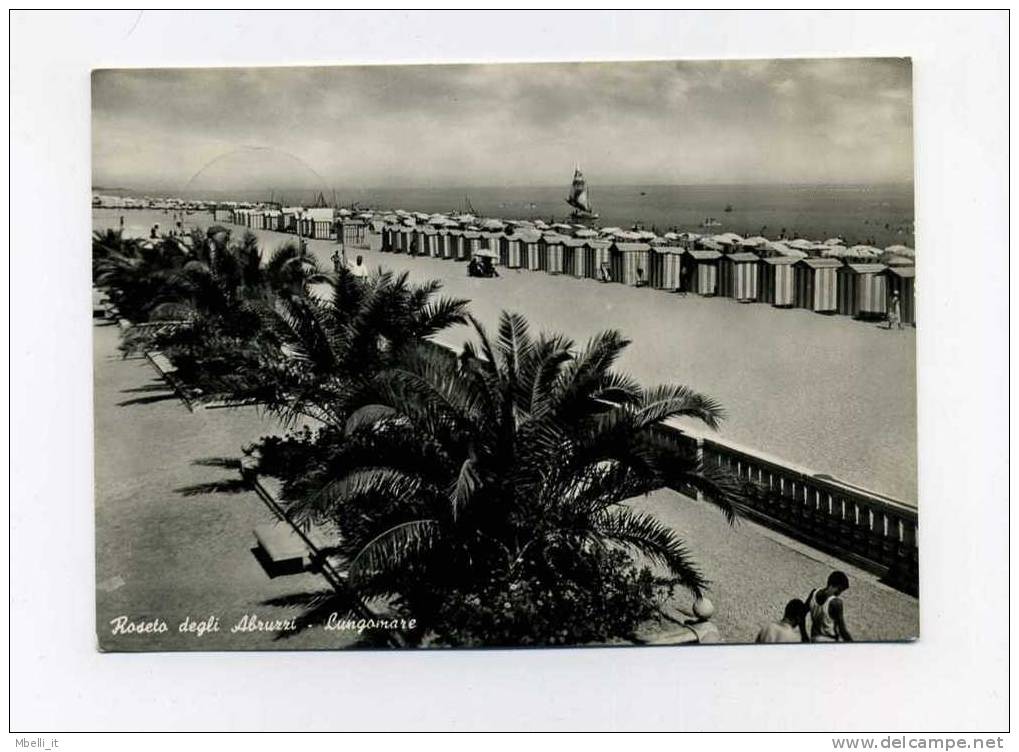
[216,207,916,324]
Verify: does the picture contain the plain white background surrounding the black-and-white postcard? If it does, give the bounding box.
[10,11,1010,729]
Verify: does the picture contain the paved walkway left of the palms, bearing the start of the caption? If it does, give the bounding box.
[93,324,354,650]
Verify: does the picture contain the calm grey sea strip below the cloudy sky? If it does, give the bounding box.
[96,182,916,248]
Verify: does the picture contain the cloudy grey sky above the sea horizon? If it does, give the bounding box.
[92,58,913,192]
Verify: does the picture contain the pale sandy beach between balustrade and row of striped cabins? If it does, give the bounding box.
[93,210,916,504]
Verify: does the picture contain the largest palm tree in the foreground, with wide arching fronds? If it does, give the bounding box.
[290,313,739,642]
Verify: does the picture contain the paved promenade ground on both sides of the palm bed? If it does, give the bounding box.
[94,315,918,650]
